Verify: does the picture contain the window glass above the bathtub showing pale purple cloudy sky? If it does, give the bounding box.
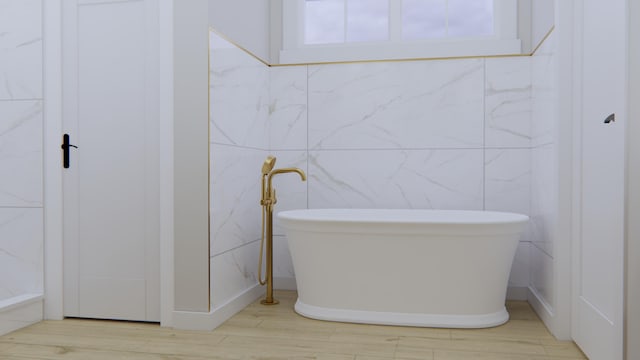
[303,0,494,45]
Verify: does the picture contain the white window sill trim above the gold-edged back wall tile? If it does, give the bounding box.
[278,39,523,65]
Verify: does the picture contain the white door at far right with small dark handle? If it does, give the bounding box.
[572,0,627,360]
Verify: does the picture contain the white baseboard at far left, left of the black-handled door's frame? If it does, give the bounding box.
[0,294,43,335]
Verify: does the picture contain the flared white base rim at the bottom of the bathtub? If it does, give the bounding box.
[294,298,509,329]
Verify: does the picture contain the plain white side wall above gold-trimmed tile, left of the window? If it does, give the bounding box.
[208,0,271,63]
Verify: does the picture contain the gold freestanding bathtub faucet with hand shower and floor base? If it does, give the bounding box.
[258,156,307,305]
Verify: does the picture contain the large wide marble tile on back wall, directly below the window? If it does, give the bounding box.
[308,59,484,150]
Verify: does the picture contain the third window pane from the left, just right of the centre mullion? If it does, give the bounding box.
[402,0,448,40]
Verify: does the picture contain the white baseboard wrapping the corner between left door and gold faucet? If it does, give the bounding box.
[173,284,263,331]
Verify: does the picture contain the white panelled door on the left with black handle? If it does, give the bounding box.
[63,0,160,321]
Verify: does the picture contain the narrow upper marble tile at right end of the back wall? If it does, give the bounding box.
[485,57,531,148]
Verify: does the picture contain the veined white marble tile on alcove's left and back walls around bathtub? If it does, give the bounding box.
[211,31,544,306]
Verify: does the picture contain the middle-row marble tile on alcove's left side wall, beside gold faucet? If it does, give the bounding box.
[210,144,266,255]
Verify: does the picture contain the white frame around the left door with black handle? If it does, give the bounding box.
[42,0,173,326]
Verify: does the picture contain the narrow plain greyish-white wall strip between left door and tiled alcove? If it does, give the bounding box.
[173,0,209,313]
